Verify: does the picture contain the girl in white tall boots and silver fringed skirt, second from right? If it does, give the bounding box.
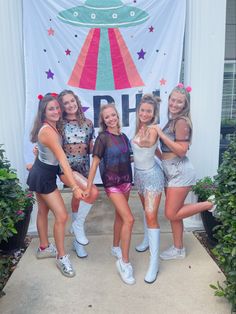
[131,94,164,283]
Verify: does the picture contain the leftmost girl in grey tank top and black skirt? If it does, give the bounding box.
[27,94,83,277]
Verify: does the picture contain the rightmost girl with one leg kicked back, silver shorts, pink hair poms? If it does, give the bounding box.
[156,83,217,260]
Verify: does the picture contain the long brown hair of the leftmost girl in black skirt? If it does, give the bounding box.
[30,94,60,143]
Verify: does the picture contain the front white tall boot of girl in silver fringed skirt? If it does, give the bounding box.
[144,229,160,283]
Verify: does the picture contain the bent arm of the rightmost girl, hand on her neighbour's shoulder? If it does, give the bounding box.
[155,119,190,157]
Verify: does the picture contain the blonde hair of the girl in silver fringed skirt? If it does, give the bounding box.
[135,94,161,134]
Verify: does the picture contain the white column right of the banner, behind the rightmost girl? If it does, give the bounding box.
[184,0,226,227]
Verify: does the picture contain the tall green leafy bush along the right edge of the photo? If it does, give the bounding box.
[211,137,236,312]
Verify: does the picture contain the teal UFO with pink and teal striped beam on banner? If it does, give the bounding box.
[58,0,149,90]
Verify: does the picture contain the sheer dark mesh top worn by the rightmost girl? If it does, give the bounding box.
[160,118,192,153]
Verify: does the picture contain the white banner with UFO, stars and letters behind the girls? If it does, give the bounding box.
[23,0,186,182]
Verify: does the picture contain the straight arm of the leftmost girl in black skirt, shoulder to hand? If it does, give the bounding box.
[38,128,84,199]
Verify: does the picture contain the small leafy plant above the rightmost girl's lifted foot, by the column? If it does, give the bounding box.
[192,177,216,201]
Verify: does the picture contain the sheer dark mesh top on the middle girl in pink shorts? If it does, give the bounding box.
[93,131,133,188]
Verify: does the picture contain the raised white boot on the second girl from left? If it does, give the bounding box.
[72,201,92,245]
